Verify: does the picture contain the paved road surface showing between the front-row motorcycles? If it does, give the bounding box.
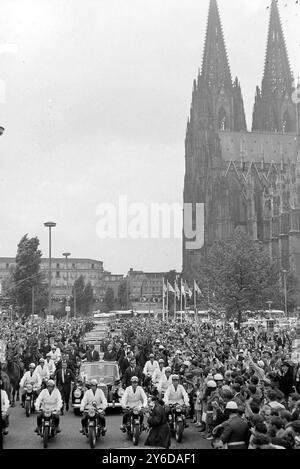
[3,402,211,450]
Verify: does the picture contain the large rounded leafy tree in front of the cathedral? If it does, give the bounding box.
[203,228,288,325]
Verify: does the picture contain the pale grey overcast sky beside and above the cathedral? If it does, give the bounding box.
[0,0,300,273]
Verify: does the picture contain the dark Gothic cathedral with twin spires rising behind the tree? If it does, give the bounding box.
[183,0,300,304]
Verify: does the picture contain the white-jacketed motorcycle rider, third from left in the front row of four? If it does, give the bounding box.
[120,376,148,433]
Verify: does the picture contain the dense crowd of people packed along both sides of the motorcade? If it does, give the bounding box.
[0,317,300,449]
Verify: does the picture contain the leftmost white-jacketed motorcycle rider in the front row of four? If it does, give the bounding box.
[34,379,62,433]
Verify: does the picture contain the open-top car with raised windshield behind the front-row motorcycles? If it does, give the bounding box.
[72,360,124,410]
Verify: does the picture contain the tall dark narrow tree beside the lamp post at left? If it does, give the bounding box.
[13,234,48,316]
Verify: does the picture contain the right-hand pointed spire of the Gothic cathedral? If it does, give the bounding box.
[252,0,296,132]
